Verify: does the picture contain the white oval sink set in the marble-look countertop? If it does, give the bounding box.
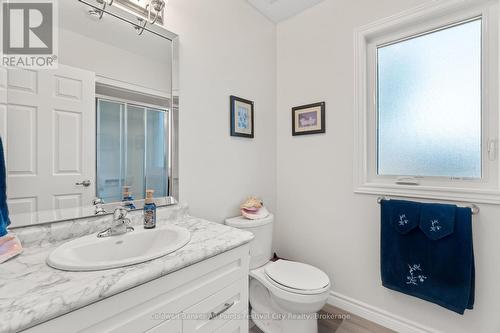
[47,225,191,271]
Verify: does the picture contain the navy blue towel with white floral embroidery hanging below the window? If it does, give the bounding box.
[381,200,475,314]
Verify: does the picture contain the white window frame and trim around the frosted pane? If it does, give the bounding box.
[354,0,500,204]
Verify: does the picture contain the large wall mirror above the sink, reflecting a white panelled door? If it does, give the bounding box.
[0,0,179,228]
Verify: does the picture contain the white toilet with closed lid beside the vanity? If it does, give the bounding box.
[226,214,330,333]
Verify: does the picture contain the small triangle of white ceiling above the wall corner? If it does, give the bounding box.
[248,0,323,23]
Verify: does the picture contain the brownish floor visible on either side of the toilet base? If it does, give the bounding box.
[249,305,396,333]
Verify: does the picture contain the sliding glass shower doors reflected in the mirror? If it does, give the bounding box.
[97,98,169,203]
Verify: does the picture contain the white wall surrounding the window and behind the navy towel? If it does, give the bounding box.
[276,0,500,333]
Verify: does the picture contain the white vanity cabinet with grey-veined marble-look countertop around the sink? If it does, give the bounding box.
[0,207,253,333]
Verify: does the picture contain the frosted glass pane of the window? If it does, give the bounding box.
[377,19,482,178]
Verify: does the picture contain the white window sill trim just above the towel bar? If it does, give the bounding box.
[354,183,500,205]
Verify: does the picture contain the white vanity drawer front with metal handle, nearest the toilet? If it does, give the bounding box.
[182,278,248,333]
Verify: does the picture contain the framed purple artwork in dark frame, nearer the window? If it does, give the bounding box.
[292,102,325,136]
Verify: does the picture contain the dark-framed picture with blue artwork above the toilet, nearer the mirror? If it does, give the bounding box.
[230,96,254,138]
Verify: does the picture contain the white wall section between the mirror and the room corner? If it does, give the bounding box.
[162,0,276,222]
